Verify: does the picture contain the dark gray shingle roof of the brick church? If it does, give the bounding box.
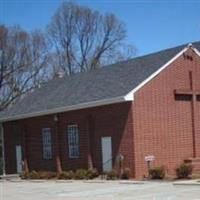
[0,42,200,121]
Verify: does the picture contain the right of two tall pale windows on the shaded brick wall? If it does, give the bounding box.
[67,124,80,159]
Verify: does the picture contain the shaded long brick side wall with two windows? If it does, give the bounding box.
[4,102,134,173]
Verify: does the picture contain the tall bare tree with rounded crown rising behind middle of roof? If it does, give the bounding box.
[48,2,134,75]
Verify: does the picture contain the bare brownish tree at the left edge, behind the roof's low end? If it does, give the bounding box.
[0,25,49,111]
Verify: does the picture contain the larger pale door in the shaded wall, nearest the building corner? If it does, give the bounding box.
[101,137,112,172]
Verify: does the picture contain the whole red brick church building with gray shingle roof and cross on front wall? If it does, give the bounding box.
[0,42,200,179]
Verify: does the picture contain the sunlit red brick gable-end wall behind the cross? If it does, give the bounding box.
[133,50,200,178]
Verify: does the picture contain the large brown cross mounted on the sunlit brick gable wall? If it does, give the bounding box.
[175,71,200,158]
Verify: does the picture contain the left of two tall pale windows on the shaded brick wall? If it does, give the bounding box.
[42,128,53,160]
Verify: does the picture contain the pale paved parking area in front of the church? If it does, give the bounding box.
[0,181,200,200]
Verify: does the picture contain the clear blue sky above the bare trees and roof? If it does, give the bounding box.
[0,0,200,55]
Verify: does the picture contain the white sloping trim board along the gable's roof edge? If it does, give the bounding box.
[124,44,200,101]
